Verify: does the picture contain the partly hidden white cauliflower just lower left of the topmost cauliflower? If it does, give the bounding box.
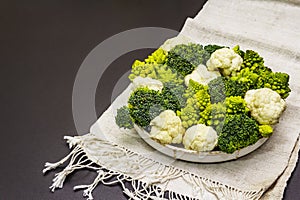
[184,65,221,86]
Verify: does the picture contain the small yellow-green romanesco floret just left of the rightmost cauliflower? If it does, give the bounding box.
[225,96,249,114]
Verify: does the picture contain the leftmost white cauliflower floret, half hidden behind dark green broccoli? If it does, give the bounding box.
[132,76,164,91]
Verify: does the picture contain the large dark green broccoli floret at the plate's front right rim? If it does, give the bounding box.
[218,114,261,153]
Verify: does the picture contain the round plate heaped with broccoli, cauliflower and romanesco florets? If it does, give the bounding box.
[115,43,291,163]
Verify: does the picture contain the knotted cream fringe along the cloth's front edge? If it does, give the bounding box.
[43,134,263,200]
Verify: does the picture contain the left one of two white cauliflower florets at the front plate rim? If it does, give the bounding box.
[150,110,185,144]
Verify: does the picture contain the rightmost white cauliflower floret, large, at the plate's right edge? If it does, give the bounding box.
[245,88,286,124]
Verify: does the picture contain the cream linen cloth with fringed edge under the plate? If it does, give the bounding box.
[45,0,300,199]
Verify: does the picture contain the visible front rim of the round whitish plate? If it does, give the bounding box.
[134,125,268,163]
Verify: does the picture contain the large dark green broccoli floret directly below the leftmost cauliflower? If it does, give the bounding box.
[128,88,164,127]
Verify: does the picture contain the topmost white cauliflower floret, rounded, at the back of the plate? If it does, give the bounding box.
[206,48,243,76]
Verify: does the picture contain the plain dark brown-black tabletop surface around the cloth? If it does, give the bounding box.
[0,0,300,200]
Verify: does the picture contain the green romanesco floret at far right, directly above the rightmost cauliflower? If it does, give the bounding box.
[257,71,291,99]
